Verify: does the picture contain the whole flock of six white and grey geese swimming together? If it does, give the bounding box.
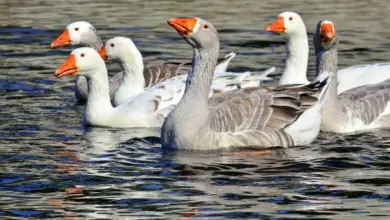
[51,12,390,150]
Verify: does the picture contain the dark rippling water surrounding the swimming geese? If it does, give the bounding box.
[0,0,390,219]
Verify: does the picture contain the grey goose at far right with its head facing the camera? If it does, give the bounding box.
[313,20,390,133]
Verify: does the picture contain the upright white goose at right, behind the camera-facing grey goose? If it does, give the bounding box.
[266,12,390,94]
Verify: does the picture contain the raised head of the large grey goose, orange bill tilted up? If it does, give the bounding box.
[168,18,219,49]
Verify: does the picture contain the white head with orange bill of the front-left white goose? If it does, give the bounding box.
[55,47,105,78]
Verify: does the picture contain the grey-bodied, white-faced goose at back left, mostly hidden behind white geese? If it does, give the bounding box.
[50,21,242,102]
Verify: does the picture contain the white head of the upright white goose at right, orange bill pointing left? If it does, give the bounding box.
[266,12,306,36]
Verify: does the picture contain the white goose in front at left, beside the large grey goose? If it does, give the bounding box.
[55,47,182,128]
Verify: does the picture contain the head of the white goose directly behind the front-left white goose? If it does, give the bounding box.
[99,37,142,64]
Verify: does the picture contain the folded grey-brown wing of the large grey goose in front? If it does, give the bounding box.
[209,82,321,147]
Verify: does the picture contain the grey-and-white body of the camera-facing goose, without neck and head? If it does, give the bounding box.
[322,80,390,133]
